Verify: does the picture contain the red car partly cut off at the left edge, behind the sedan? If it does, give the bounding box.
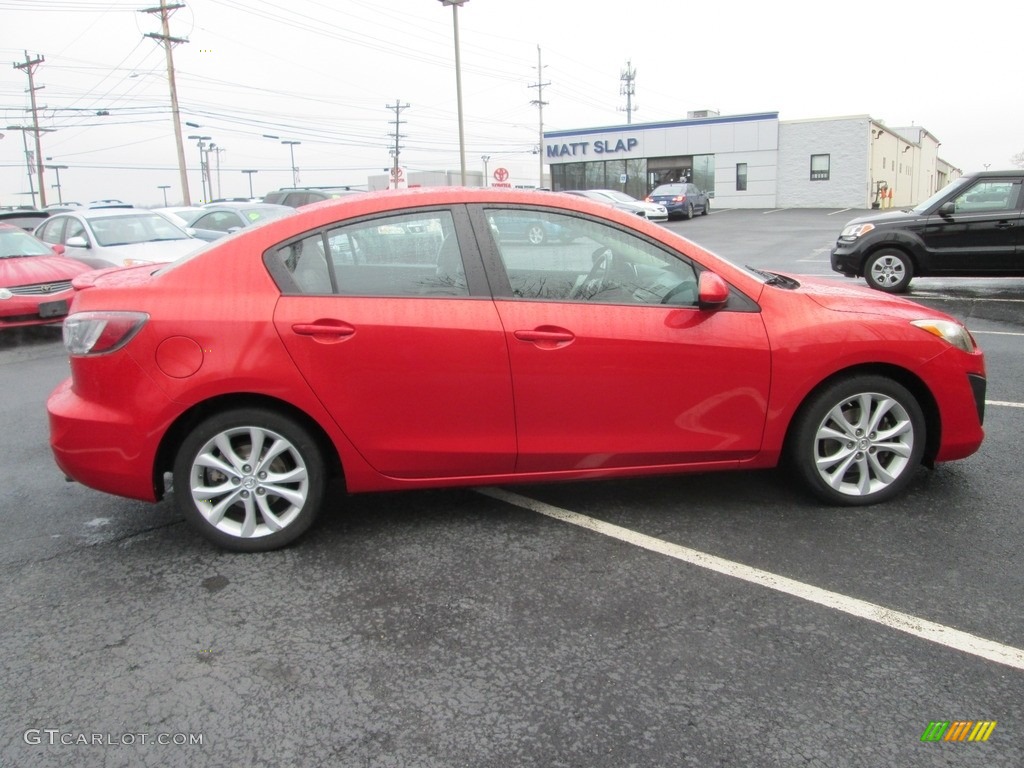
[0,224,92,329]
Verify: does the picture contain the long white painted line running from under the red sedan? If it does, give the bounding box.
[477,488,1024,670]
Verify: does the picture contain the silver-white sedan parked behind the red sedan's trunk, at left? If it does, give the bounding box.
[35,208,206,269]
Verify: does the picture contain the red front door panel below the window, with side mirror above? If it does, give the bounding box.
[498,300,770,472]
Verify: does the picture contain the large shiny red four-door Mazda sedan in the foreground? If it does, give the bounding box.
[48,188,985,551]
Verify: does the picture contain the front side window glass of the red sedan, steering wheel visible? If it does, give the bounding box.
[484,209,697,306]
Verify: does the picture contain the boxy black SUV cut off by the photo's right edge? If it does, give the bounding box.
[831,171,1024,293]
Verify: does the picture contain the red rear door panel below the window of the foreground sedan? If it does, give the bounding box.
[274,296,515,477]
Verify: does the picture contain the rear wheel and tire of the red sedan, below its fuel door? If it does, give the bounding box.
[174,409,327,552]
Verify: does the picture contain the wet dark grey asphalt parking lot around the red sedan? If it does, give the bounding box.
[0,210,1024,768]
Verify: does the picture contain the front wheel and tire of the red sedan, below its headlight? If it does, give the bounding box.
[787,375,927,506]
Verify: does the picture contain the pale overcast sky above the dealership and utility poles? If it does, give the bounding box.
[0,0,1024,205]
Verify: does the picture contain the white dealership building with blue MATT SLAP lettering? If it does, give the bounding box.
[544,111,959,208]
